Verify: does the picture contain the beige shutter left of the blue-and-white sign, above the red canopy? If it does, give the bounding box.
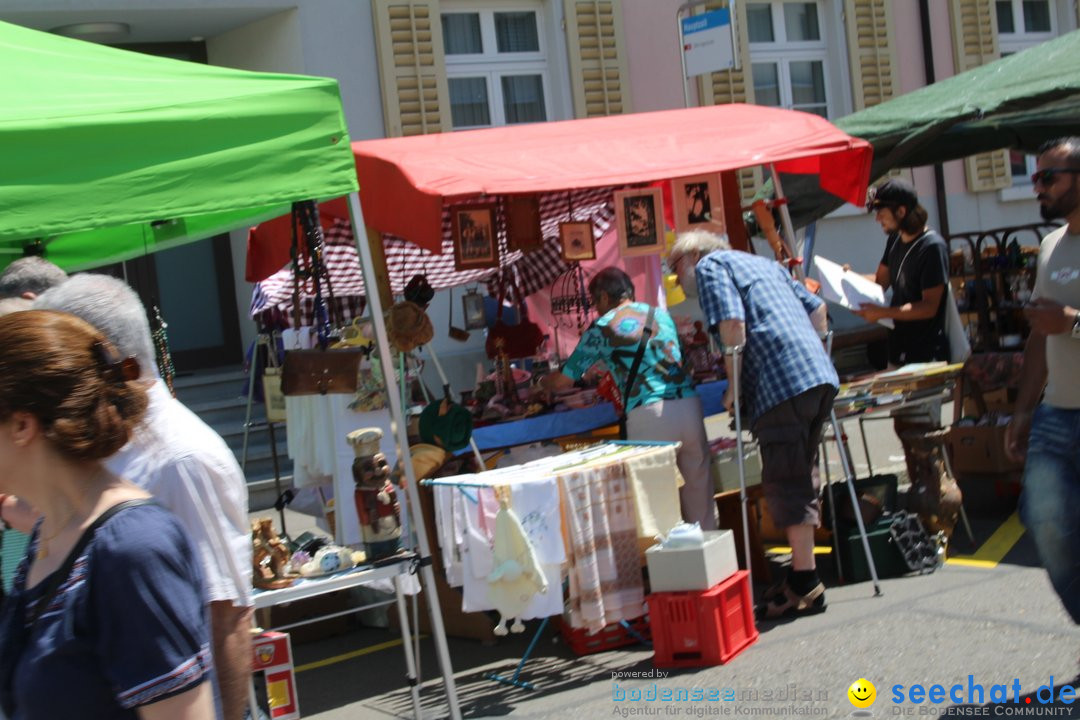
[564,0,631,118]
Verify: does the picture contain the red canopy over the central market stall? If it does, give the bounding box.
[247,105,872,280]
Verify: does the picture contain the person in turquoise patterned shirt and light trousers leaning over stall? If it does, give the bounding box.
[543,268,716,530]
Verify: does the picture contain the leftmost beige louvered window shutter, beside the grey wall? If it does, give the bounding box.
[372,0,450,137]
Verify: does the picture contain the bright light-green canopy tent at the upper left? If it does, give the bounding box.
[0,23,356,270]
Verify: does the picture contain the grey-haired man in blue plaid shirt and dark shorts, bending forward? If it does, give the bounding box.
[667,230,839,617]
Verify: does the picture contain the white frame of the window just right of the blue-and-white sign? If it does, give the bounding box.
[747,0,842,118]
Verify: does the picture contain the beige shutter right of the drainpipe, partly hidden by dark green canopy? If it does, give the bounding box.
[949,0,1012,192]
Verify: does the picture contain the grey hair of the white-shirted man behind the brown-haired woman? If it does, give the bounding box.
[33,273,158,378]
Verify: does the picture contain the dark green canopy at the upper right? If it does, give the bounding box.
[781,30,1080,226]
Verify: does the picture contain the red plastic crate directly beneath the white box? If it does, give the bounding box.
[648,570,757,667]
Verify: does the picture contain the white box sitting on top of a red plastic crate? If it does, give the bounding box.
[645,530,739,593]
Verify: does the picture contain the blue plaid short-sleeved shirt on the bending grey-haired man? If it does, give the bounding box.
[696,250,839,422]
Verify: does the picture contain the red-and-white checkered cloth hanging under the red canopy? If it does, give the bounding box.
[251,188,615,322]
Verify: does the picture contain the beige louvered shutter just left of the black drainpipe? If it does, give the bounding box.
[843,0,897,110]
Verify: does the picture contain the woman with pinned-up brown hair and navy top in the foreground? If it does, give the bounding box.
[0,310,217,720]
